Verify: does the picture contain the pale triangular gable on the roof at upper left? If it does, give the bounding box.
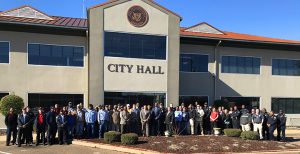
[0,5,53,20]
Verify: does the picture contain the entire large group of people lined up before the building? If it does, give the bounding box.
[5,102,286,147]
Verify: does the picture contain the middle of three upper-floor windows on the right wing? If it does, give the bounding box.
[222,56,260,74]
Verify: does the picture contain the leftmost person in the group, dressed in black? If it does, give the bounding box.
[5,108,18,146]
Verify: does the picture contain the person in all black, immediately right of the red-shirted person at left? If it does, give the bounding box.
[46,107,57,145]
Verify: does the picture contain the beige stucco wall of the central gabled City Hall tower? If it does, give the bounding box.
[89,0,180,104]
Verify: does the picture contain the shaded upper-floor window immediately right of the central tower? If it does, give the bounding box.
[180,54,208,72]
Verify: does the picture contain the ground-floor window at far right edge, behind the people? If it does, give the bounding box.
[272,98,300,114]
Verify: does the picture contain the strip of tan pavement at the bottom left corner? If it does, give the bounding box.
[0,142,123,154]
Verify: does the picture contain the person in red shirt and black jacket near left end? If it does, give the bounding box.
[34,108,47,146]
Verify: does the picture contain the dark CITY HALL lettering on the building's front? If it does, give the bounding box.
[107,64,165,74]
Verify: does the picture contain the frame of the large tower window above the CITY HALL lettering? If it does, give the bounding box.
[102,30,169,61]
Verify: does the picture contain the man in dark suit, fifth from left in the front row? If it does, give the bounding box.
[56,111,69,145]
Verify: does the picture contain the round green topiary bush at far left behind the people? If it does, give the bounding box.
[0,95,24,115]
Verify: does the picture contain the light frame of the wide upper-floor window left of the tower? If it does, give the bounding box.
[26,42,86,69]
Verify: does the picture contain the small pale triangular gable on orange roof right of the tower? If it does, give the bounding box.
[184,22,224,35]
